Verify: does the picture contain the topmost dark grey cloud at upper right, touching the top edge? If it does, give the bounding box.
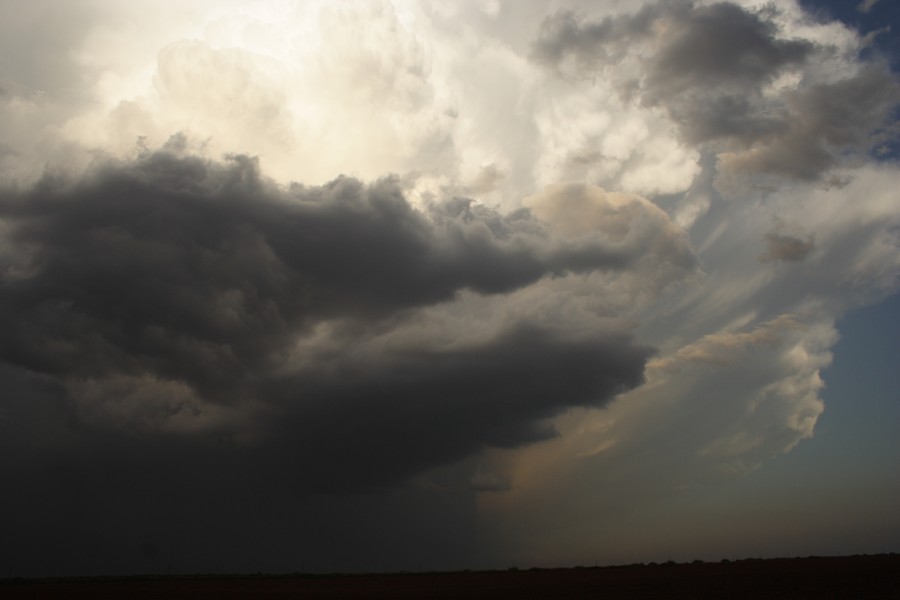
[532,2,813,95]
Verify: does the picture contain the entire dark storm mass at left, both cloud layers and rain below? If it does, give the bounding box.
[0,144,652,575]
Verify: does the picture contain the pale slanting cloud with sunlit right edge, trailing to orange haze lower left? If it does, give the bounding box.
[484,315,836,561]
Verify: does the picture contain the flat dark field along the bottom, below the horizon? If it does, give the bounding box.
[0,554,900,600]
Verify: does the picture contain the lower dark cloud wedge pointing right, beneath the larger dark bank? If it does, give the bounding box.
[266,327,651,487]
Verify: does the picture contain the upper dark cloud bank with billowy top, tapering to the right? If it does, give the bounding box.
[0,148,629,386]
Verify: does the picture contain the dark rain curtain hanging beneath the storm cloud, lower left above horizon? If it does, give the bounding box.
[0,365,479,577]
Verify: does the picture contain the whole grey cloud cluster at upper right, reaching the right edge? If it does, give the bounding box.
[533,2,900,180]
